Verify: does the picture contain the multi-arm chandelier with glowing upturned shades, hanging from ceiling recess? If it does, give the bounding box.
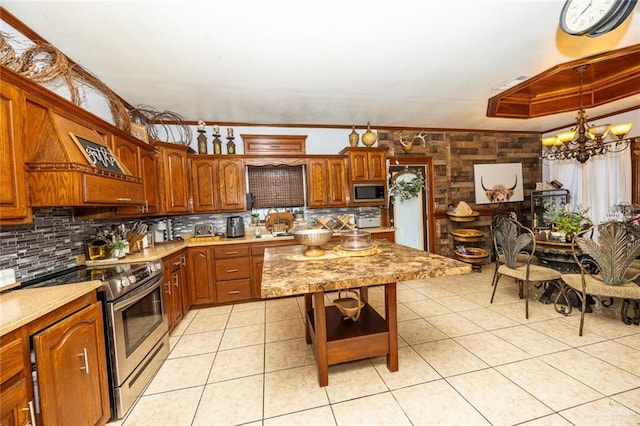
[541,64,640,164]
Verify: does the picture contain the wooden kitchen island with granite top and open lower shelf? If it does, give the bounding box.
[261,240,471,386]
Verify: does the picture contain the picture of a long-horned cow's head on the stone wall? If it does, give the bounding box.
[473,163,524,204]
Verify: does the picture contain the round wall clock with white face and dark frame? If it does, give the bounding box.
[560,0,638,37]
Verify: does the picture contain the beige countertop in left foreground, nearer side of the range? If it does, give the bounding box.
[0,280,101,336]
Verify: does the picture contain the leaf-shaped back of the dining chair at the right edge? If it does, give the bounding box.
[573,222,640,285]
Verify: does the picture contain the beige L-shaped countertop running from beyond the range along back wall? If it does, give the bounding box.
[85,227,395,266]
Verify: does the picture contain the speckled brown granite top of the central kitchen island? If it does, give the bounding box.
[261,240,472,298]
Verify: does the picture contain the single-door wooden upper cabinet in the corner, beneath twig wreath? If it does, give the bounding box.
[154,142,191,214]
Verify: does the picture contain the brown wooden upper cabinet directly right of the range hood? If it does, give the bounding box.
[112,135,160,216]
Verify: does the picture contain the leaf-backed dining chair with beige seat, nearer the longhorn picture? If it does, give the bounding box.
[490,216,562,319]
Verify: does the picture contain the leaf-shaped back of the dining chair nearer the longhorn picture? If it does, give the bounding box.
[491,215,536,268]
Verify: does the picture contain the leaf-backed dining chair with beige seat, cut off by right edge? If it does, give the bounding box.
[562,222,640,336]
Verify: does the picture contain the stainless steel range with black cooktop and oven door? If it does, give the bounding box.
[22,261,169,419]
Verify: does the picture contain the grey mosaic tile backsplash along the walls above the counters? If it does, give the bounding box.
[0,207,380,281]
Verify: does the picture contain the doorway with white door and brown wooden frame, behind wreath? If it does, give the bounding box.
[389,156,435,252]
